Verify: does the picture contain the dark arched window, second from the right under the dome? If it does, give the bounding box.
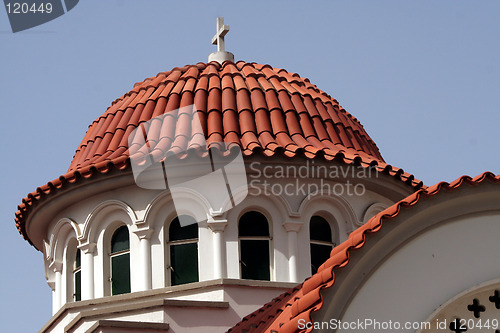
[238,211,271,281]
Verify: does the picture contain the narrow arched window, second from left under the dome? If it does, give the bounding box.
[110,226,130,295]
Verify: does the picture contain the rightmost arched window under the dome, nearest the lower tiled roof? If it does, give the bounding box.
[309,216,335,274]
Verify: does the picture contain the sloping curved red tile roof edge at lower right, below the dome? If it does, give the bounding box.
[228,172,500,333]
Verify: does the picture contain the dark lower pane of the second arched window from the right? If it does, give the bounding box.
[240,239,271,281]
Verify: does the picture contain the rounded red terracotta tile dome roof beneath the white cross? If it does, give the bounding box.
[16,61,423,245]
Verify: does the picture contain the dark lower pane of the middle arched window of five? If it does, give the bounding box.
[170,242,198,286]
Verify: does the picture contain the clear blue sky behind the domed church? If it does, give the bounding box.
[0,0,500,333]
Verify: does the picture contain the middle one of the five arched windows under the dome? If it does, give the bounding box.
[168,215,199,286]
